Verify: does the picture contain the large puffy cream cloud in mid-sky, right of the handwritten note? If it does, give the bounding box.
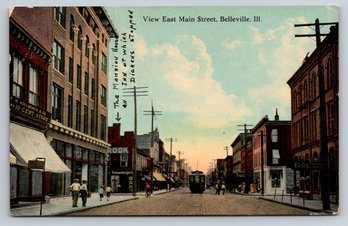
[136,35,249,128]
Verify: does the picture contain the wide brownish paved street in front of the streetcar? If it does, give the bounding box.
[69,188,312,216]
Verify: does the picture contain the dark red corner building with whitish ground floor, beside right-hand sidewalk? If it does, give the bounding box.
[251,112,294,194]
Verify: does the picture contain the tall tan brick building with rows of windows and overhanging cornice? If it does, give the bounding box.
[47,7,117,195]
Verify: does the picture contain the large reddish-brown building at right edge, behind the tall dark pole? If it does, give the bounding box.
[288,26,339,201]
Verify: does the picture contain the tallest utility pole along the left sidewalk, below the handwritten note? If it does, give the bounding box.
[123,86,148,196]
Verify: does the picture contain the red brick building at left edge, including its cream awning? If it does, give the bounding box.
[9,7,70,204]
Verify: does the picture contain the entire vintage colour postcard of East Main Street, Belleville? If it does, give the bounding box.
[9,5,340,217]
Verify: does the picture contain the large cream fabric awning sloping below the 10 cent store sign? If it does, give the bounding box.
[10,123,71,173]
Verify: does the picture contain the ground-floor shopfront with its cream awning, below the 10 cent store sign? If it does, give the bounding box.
[10,122,70,202]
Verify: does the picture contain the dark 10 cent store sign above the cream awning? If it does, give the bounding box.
[10,96,51,125]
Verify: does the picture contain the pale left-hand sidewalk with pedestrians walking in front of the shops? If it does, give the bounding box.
[10,189,175,216]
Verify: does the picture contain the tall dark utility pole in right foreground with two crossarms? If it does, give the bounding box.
[294,18,338,210]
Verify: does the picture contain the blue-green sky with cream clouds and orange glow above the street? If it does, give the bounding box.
[106,6,339,172]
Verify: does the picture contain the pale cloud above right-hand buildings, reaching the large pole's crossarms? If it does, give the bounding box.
[249,17,315,117]
